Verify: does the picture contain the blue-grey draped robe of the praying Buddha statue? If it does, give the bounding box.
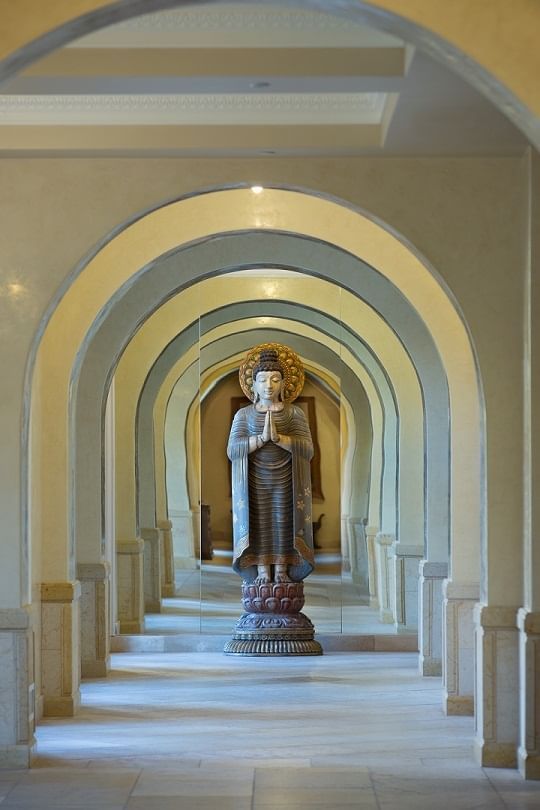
[227,403,314,582]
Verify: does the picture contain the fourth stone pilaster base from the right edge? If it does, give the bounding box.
[418,560,448,676]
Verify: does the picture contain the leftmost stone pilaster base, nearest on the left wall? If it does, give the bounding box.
[0,608,35,768]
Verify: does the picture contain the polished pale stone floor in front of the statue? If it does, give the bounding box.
[0,653,540,810]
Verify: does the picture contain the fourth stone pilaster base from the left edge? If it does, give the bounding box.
[116,538,144,633]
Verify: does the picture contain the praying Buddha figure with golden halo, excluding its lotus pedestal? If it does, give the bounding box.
[227,344,314,585]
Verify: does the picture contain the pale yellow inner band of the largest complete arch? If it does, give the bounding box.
[32,188,483,604]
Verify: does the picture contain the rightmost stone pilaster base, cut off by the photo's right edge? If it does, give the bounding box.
[517,608,540,779]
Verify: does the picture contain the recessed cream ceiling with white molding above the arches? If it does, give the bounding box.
[0,3,526,156]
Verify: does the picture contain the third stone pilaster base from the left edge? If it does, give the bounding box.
[77,562,111,678]
